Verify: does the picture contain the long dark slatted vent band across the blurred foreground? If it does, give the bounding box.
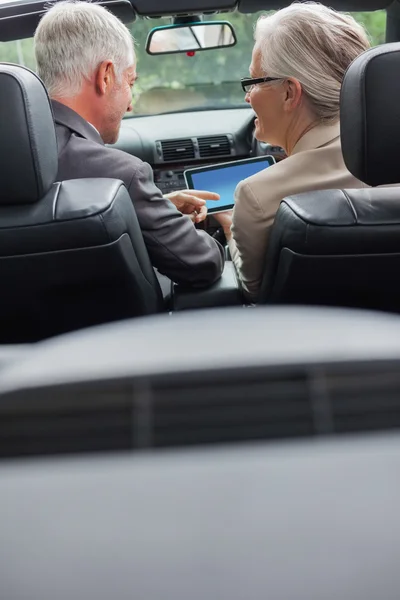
[0,363,400,458]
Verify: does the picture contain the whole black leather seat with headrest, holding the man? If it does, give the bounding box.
[0,64,163,343]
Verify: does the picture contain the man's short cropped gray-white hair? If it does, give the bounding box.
[34,0,135,98]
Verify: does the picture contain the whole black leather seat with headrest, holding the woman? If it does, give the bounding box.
[260,43,400,312]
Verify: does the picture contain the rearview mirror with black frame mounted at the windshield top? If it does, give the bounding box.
[146,21,236,54]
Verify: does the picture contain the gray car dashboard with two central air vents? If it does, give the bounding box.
[114,106,284,194]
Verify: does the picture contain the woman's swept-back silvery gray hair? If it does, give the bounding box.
[255,2,370,122]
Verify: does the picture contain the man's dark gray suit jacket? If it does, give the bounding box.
[52,101,224,286]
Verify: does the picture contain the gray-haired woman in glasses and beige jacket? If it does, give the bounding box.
[215,2,369,301]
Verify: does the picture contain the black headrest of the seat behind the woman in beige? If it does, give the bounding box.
[340,42,400,186]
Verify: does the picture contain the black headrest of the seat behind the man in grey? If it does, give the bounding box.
[0,64,58,205]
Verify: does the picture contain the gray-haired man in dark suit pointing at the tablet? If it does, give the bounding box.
[35,1,224,286]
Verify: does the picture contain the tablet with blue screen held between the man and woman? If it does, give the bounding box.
[184,156,275,214]
